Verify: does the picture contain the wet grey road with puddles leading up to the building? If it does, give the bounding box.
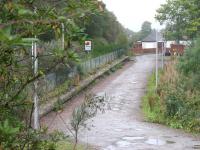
[41,55,200,150]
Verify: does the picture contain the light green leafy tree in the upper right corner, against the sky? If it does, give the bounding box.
[156,0,200,42]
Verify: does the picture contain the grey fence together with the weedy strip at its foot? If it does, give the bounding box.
[38,49,125,101]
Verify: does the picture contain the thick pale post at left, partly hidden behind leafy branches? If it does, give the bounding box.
[31,36,40,130]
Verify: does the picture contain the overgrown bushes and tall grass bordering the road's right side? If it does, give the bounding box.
[143,38,200,133]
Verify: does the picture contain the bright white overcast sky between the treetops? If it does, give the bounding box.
[102,0,166,31]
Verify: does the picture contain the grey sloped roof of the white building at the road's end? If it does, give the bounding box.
[142,30,164,42]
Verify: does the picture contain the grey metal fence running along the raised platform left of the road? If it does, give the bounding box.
[38,49,125,96]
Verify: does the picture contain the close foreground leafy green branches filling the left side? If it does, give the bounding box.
[0,0,98,150]
